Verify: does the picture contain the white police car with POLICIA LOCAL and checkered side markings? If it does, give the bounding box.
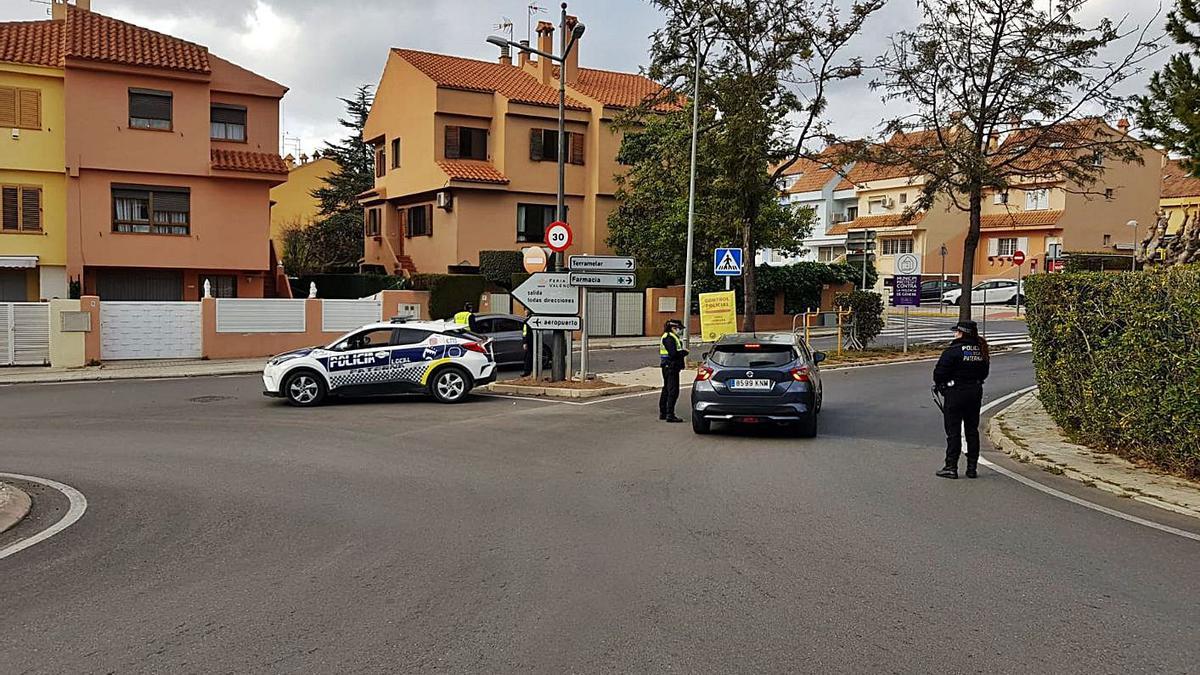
[263,319,496,406]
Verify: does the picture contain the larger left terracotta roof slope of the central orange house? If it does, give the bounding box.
[392,48,587,110]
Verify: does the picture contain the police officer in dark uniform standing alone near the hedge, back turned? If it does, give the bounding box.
[934,321,991,478]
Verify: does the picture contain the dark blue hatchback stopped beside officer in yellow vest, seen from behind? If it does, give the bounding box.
[691,334,824,438]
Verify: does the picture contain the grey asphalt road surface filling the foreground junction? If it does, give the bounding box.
[0,354,1200,675]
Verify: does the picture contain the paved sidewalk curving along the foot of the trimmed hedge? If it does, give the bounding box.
[988,392,1200,518]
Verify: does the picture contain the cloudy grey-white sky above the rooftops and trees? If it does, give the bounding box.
[0,0,1174,151]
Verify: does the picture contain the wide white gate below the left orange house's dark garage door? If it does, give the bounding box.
[100,303,200,360]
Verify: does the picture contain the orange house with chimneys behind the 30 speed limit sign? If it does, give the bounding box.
[361,22,660,273]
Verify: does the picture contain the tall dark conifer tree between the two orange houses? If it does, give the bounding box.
[305,84,374,269]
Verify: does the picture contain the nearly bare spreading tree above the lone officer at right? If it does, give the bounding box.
[866,0,1157,319]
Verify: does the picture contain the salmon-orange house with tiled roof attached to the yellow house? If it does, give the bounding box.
[16,0,287,300]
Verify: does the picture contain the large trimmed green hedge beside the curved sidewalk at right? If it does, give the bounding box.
[1026,268,1200,478]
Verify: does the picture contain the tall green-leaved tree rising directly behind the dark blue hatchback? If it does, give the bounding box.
[633,0,886,330]
